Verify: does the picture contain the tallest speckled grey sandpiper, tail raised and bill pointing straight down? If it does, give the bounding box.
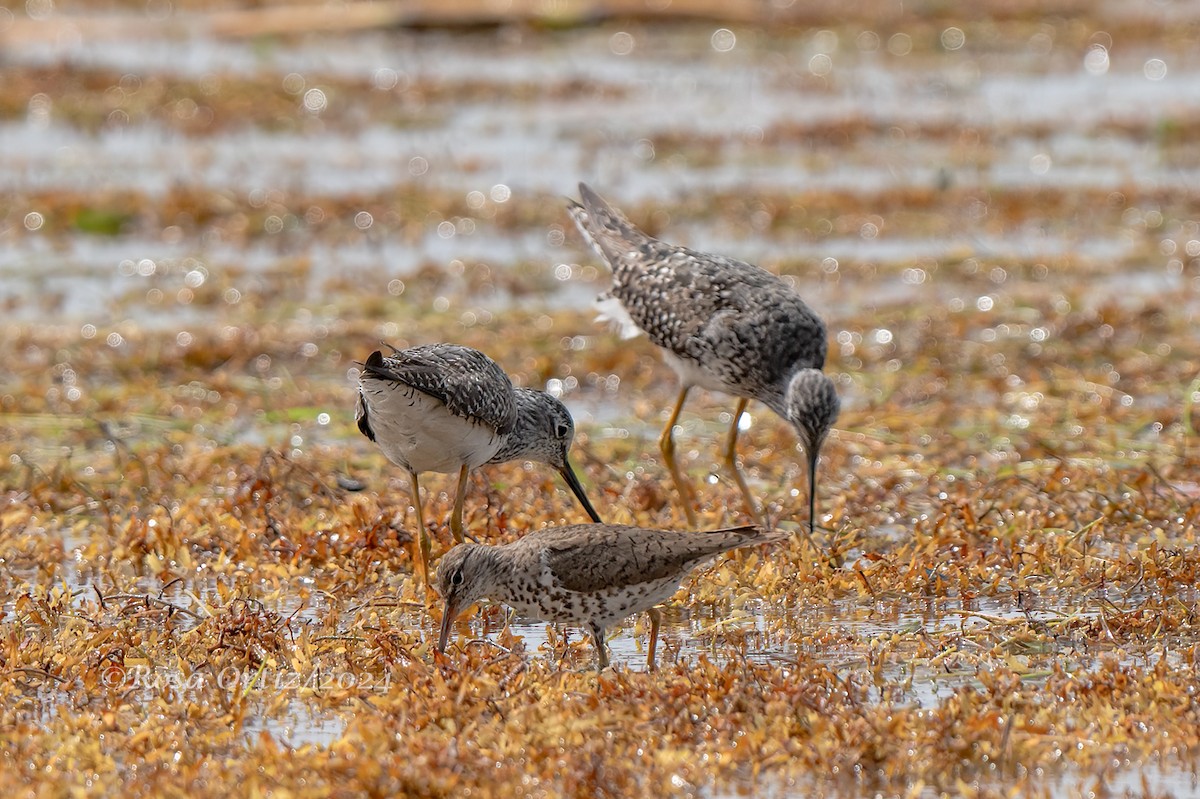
[569,184,840,534]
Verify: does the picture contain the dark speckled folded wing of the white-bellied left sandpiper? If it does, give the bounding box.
[362,344,517,435]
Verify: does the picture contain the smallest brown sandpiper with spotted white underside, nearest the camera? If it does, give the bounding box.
[437,524,787,669]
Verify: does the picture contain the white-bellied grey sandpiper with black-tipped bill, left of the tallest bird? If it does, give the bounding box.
[355,344,600,585]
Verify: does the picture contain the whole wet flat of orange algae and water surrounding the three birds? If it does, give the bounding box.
[0,2,1200,797]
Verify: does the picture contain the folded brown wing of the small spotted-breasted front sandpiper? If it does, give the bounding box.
[537,524,786,593]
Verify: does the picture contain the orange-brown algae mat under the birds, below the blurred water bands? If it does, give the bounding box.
[0,283,1200,795]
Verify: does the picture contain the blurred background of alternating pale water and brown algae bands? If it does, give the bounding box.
[0,0,1200,337]
